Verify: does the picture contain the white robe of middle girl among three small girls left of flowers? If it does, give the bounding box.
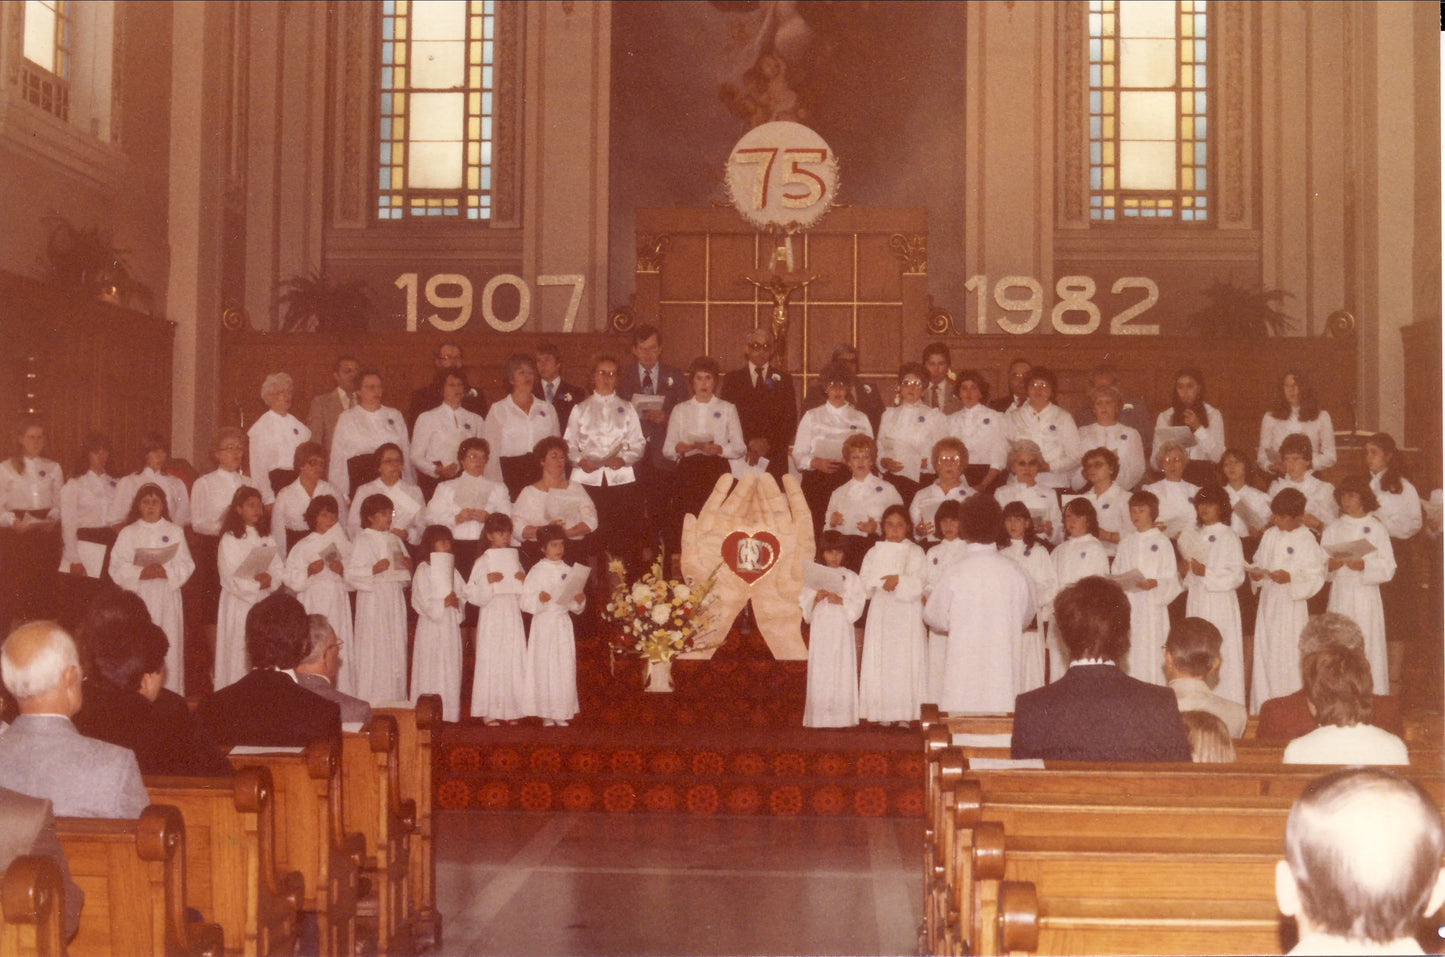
[467,555,528,721]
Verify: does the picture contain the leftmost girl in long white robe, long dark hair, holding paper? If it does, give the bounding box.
[108,481,195,694]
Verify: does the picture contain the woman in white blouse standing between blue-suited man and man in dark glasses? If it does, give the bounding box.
[662,356,747,540]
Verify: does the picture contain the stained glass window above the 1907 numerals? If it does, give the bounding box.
[377,0,497,220]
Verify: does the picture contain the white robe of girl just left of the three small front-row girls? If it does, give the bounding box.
[347,529,412,704]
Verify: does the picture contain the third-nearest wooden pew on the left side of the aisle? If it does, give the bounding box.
[146,768,305,957]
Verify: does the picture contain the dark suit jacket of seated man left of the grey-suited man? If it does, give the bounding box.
[195,668,341,750]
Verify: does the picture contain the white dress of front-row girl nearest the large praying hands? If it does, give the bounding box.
[798,568,867,727]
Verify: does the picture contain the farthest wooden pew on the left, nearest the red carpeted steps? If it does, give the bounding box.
[371,694,442,950]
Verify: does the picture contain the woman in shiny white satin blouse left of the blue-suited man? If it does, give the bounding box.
[565,356,647,572]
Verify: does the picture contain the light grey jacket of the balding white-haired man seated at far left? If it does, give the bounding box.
[0,714,150,817]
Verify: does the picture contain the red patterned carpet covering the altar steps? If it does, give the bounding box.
[436,632,922,817]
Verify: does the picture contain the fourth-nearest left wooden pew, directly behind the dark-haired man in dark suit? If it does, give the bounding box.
[231,742,366,957]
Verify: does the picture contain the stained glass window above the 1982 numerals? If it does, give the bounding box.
[1088,0,1209,223]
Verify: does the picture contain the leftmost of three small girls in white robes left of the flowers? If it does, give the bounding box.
[412,525,467,721]
